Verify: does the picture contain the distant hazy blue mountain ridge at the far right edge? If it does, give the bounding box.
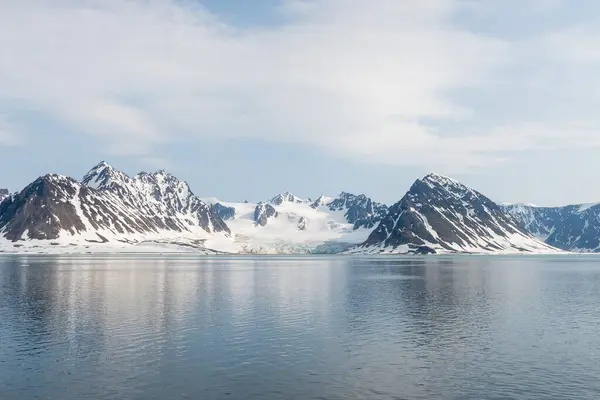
[503,204,600,252]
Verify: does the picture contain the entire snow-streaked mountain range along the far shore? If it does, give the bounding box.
[0,162,600,254]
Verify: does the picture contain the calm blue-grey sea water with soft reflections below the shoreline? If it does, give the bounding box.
[0,256,600,400]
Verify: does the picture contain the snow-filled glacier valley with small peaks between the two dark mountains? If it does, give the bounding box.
[207,192,386,253]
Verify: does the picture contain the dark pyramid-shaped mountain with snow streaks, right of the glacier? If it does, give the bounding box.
[351,174,555,253]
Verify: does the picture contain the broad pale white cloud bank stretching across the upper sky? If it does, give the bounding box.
[0,0,593,169]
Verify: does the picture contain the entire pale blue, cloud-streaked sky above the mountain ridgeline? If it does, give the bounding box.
[0,0,600,206]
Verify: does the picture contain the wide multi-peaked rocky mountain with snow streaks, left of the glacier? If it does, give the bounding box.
[0,162,230,252]
